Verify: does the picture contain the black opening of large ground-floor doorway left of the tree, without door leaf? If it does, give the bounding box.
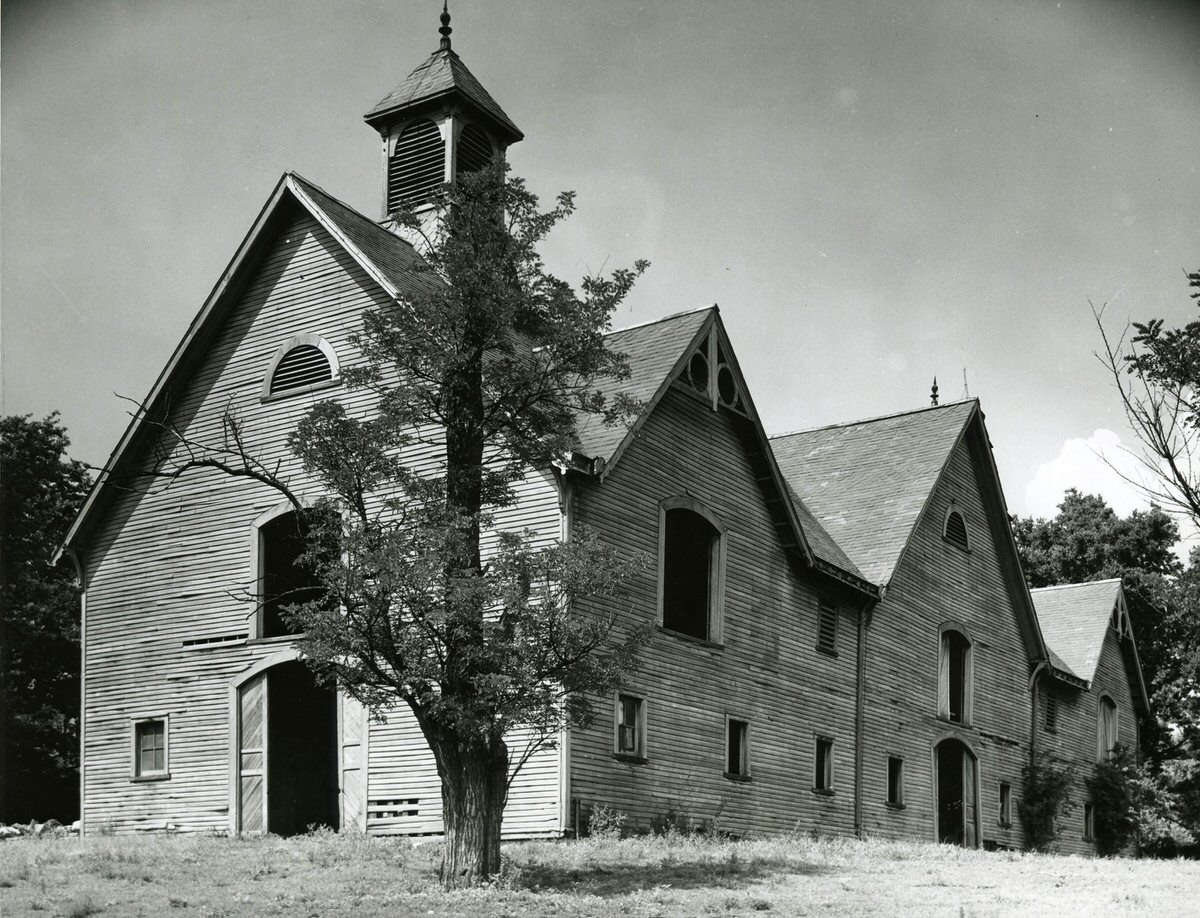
[266,662,340,835]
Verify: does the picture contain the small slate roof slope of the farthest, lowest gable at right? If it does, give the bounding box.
[1030,578,1121,682]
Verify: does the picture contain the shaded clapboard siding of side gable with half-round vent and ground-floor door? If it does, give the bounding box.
[863,442,1031,846]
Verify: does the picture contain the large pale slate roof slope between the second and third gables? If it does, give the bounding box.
[770,400,978,584]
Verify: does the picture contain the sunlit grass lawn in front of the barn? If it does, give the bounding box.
[0,833,1200,918]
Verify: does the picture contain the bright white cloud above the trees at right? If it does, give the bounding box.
[1025,430,1150,517]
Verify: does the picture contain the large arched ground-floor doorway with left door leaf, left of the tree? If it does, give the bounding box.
[238,661,341,835]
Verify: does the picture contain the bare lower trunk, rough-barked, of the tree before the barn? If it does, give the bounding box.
[439,739,509,889]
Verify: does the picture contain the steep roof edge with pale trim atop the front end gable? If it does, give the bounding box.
[55,172,438,558]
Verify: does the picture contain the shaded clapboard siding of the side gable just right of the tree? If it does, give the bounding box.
[570,389,854,833]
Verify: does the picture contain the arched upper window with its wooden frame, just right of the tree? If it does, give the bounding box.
[659,498,724,641]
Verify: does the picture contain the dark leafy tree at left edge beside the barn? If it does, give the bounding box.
[0,413,89,822]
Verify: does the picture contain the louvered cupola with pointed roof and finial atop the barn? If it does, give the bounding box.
[364,5,524,221]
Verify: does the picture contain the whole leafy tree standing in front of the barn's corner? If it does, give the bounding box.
[145,164,647,887]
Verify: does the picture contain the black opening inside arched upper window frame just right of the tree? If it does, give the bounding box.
[662,509,720,640]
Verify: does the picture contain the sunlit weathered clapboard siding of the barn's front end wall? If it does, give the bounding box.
[83,209,558,832]
